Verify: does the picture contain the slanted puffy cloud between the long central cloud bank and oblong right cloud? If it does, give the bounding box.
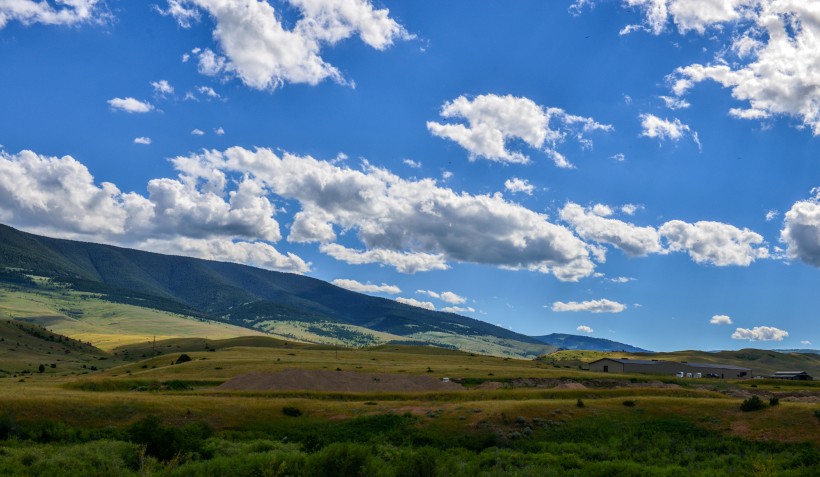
[560,202,663,257]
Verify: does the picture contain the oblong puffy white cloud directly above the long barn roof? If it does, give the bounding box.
[658,220,769,267]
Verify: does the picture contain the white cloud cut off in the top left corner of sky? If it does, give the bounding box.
[0,0,109,28]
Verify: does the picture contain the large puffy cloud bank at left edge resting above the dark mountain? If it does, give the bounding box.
[0,151,309,273]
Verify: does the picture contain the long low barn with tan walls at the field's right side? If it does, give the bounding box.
[589,358,752,379]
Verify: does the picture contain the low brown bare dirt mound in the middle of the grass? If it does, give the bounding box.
[216,369,464,393]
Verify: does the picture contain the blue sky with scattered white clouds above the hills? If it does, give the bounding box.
[0,0,820,350]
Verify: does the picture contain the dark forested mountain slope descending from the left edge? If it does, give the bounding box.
[0,225,553,357]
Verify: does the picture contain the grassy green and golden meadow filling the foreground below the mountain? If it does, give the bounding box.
[0,328,820,476]
